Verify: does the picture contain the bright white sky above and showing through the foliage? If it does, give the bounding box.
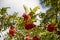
[0,0,47,40]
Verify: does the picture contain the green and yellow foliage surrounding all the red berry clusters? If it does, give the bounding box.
[0,0,60,40]
